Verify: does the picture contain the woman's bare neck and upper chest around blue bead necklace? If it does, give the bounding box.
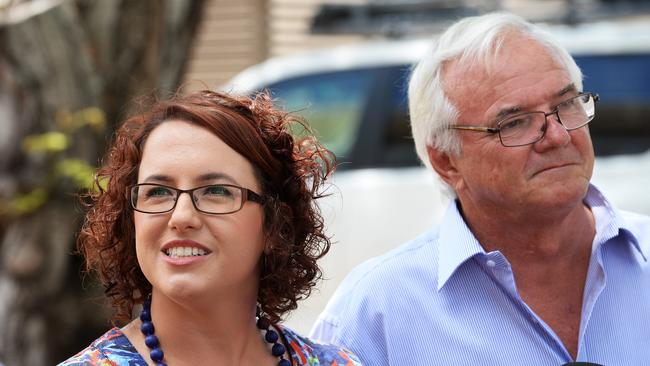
[125,292,277,366]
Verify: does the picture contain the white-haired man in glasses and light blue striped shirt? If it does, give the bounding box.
[312,14,650,366]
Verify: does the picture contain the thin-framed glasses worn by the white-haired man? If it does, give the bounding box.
[449,93,599,147]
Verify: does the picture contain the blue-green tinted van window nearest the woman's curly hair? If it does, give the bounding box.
[267,70,372,158]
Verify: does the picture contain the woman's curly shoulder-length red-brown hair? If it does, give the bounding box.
[77,90,335,322]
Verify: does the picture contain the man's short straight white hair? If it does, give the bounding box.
[408,12,582,167]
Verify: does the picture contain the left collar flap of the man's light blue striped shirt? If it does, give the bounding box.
[438,200,485,291]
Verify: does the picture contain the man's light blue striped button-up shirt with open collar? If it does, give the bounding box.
[311,186,650,366]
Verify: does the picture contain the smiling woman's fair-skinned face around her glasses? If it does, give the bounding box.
[134,120,264,301]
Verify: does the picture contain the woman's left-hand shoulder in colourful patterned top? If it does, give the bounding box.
[58,328,147,366]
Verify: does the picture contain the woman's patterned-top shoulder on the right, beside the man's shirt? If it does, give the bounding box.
[280,326,361,366]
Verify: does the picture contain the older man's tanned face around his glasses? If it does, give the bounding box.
[443,35,594,218]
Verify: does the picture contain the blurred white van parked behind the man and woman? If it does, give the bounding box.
[224,22,650,333]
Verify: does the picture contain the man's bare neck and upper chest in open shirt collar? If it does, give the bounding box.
[454,197,596,357]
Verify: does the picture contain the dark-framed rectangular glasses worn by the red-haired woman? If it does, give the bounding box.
[129,183,265,215]
